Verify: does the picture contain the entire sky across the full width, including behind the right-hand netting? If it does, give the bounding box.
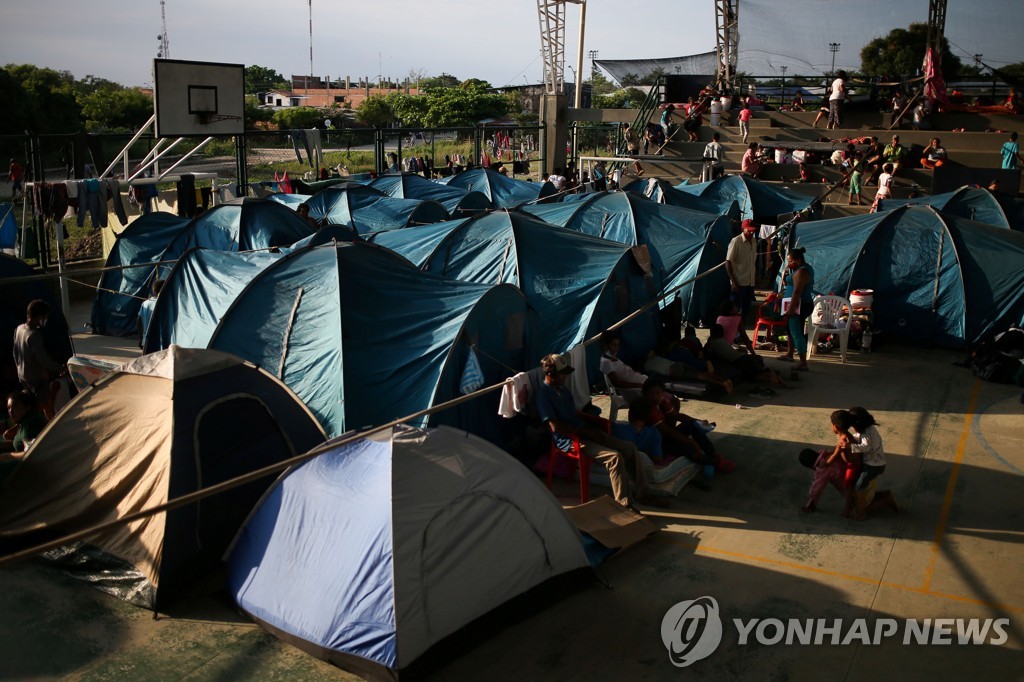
[0,0,1024,86]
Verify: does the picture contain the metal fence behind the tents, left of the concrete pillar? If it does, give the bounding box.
[0,126,545,268]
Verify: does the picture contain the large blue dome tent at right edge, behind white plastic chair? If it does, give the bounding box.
[795,206,1024,346]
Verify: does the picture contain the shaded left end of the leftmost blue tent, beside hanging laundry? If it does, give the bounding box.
[91,212,188,336]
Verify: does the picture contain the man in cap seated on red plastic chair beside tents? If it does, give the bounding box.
[537,354,667,507]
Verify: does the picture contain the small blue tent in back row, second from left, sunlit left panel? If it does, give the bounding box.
[308,187,451,235]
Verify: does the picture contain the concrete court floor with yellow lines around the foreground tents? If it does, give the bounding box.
[0,303,1024,681]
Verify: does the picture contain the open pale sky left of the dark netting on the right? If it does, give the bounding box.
[0,0,715,86]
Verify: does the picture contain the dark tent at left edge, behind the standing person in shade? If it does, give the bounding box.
[0,253,75,393]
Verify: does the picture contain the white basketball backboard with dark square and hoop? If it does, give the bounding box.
[153,59,245,137]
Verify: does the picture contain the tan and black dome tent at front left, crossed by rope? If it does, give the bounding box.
[0,346,326,609]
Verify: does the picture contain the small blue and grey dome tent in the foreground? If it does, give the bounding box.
[228,427,592,679]
